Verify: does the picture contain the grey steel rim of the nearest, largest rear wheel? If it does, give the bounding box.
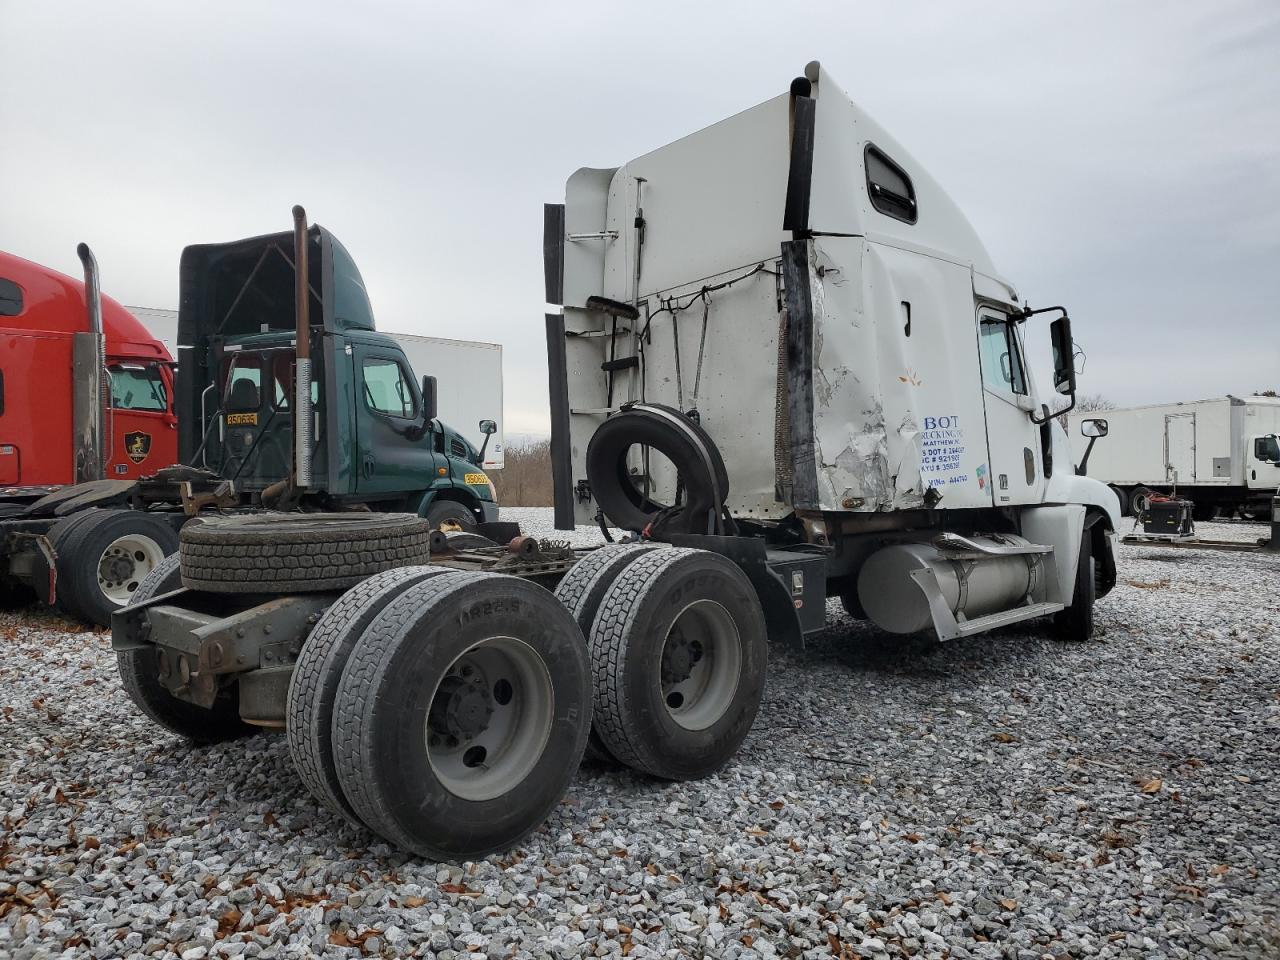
[424,636,556,801]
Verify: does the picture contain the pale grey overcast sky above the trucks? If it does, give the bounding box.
[0,0,1280,435]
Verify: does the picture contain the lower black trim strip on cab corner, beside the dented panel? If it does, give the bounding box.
[782,241,818,509]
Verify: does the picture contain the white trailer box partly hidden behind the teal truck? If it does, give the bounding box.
[127,307,503,470]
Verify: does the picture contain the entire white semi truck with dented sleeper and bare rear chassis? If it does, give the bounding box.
[111,64,1120,859]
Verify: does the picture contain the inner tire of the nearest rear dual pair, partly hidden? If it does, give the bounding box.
[285,567,448,826]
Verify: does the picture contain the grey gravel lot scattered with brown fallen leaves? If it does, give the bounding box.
[0,509,1280,960]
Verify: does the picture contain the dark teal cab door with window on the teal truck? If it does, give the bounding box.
[352,344,443,498]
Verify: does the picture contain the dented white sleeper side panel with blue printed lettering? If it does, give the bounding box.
[813,238,991,512]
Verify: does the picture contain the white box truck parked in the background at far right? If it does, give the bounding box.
[1088,397,1280,520]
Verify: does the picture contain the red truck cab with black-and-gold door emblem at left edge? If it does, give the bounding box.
[0,252,178,499]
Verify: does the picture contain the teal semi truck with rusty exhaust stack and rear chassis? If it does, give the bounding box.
[0,207,498,626]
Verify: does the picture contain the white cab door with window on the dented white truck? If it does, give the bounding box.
[978,307,1044,507]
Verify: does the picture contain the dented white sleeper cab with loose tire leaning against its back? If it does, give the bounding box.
[545,63,1120,655]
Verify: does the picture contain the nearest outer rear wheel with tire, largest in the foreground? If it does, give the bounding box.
[333,572,591,860]
